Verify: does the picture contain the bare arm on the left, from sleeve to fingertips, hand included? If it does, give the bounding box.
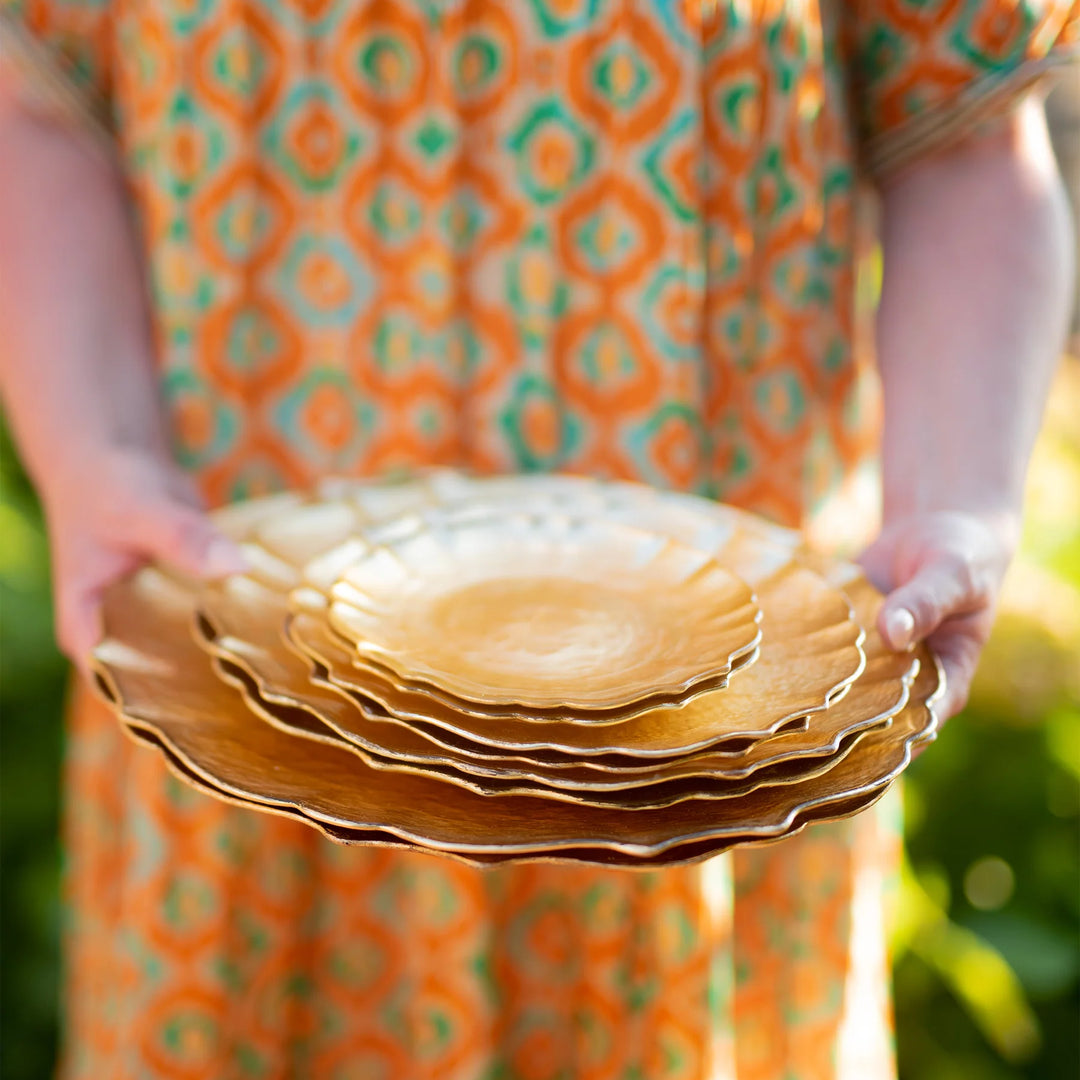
[0,90,245,662]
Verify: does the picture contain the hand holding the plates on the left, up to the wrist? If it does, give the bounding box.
[42,449,245,670]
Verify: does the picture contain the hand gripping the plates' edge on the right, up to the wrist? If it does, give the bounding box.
[860,511,1020,720]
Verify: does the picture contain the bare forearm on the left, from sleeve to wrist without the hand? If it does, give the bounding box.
[0,87,167,499]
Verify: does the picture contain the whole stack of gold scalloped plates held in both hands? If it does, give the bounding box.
[95,471,943,867]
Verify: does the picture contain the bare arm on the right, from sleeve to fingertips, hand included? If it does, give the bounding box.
[863,92,1074,715]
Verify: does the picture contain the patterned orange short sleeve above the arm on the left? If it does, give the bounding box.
[0,0,112,134]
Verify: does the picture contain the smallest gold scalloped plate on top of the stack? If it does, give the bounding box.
[327,513,760,720]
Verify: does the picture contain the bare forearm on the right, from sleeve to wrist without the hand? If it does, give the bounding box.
[878,102,1074,524]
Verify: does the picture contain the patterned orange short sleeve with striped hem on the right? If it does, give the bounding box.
[841,0,1080,177]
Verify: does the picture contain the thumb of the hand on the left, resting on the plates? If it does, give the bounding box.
[127,498,248,578]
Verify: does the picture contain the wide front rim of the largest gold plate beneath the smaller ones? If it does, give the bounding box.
[95,567,941,858]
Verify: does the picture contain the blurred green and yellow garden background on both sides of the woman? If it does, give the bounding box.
[0,73,1080,1080]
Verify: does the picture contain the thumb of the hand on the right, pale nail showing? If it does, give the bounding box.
[878,553,989,650]
